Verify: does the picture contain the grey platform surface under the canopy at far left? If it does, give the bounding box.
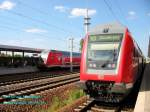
[0,66,38,75]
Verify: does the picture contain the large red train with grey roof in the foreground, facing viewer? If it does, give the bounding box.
[80,23,144,102]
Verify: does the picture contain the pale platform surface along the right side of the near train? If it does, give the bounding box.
[134,64,150,112]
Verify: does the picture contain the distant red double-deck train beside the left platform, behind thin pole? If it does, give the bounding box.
[39,50,81,68]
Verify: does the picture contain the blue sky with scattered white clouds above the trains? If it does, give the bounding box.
[0,0,150,56]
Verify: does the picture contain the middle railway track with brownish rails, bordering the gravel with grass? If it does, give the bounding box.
[0,74,79,103]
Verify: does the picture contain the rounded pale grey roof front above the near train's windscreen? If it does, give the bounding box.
[89,22,127,35]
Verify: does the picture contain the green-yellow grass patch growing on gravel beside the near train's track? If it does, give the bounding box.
[39,89,85,112]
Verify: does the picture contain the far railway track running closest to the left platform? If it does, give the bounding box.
[0,71,78,87]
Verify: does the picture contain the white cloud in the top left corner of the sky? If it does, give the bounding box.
[0,1,15,10]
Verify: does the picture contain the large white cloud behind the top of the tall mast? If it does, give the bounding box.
[70,8,96,17]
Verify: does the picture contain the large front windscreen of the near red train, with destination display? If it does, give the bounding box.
[87,34,122,69]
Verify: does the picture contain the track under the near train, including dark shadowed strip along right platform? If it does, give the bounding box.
[74,77,141,112]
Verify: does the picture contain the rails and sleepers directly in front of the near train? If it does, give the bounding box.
[74,99,134,112]
